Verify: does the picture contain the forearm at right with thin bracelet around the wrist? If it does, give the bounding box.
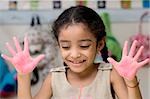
[125,77,142,99]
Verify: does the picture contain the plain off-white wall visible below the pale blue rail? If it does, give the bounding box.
[0,19,150,99]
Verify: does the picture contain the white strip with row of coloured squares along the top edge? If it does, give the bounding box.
[0,0,150,10]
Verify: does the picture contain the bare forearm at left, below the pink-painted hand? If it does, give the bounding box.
[17,74,32,99]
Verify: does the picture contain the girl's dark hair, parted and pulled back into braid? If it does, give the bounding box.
[52,5,108,62]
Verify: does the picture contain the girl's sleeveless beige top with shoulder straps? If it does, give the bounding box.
[51,63,113,99]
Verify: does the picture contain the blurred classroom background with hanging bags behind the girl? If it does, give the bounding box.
[0,0,150,99]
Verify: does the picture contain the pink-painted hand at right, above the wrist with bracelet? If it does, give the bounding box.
[107,41,150,80]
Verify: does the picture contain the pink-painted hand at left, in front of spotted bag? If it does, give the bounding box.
[2,36,44,74]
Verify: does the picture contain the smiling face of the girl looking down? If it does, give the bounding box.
[58,23,100,73]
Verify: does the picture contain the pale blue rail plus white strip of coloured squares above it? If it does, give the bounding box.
[0,0,150,25]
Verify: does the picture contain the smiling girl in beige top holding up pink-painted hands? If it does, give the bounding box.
[2,6,149,99]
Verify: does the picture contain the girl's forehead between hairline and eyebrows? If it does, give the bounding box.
[58,23,96,41]
